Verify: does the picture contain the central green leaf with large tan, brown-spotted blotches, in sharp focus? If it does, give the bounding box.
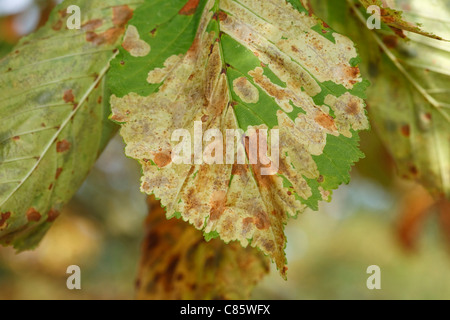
[110,0,368,276]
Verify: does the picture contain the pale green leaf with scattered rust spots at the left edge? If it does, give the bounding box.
[0,0,142,250]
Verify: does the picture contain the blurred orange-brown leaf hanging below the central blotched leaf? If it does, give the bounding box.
[136,197,269,300]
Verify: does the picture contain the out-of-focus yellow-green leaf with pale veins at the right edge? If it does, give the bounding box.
[312,0,450,198]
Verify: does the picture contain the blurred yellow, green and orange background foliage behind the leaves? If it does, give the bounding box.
[0,0,450,299]
